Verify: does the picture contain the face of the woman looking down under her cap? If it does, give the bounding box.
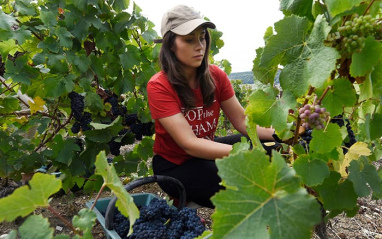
[171,27,207,69]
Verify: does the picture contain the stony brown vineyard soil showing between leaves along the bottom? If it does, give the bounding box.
[0,160,382,239]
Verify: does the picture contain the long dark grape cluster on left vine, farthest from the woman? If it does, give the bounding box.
[68,91,92,134]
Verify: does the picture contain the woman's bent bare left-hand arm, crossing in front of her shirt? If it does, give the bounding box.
[158,113,232,160]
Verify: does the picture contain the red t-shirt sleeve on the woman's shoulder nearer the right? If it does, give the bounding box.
[211,65,235,102]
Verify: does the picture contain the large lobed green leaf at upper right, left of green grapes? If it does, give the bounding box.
[260,15,340,96]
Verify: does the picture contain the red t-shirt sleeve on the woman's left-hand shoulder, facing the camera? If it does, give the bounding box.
[147,75,181,119]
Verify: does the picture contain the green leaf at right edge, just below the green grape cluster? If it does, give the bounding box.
[350,36,382,77]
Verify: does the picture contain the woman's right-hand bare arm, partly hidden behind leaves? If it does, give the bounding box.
[221,95,274,141]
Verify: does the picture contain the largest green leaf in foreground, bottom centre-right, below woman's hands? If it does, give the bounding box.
[212,149,320,239]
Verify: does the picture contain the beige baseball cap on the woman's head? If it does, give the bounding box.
[158,5,216,40]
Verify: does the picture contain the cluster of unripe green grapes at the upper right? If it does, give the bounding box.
[336,15,381,53]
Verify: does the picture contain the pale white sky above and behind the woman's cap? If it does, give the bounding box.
[131,0,283,72]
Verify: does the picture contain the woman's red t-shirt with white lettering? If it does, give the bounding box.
[147,65,235,165]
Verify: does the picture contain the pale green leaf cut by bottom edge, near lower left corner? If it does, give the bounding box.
[19,215,54,239]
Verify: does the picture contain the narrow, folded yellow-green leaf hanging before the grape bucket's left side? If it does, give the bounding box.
[95,151,139,235]
